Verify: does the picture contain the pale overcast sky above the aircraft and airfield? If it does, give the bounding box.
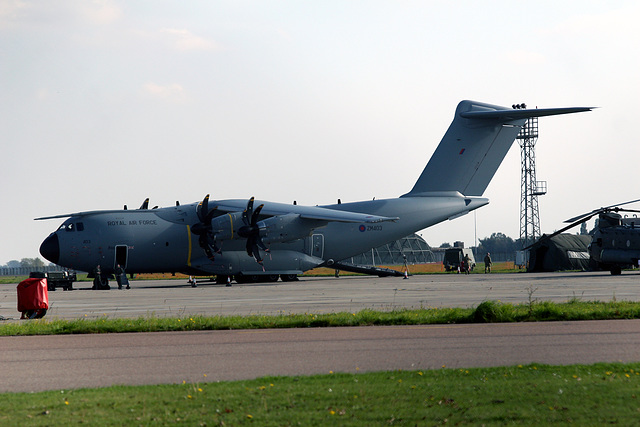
[0,0,640,265]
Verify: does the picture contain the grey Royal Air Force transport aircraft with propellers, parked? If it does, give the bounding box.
[36,101,591,288]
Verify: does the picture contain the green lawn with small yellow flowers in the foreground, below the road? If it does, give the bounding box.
[0,364,640,426]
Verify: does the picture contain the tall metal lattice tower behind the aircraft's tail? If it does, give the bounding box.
[516,117,547,247]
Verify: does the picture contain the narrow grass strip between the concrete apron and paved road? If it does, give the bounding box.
[0,299,640,336]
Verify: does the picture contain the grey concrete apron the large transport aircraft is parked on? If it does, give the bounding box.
[0,271,640,319]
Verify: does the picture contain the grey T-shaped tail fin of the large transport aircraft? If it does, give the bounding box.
[402,101,592,197]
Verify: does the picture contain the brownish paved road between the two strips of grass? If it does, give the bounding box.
[0,320,640,392]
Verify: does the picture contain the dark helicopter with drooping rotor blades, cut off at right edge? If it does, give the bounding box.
[524,199,640,276]
